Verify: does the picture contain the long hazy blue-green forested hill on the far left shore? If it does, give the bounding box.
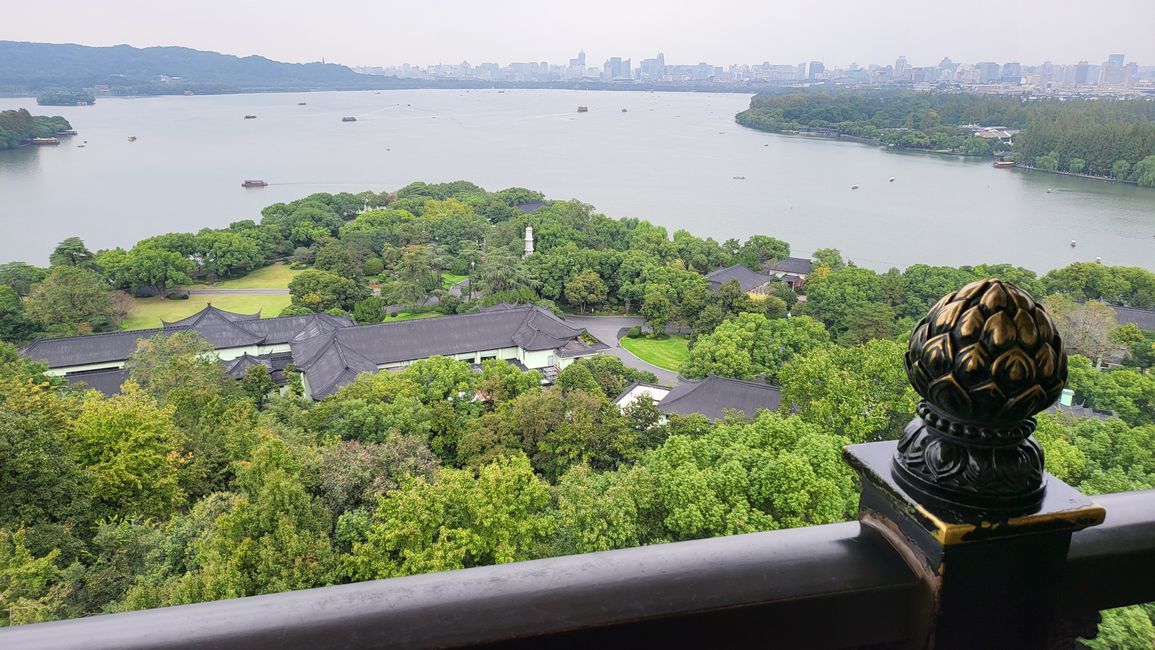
[0,40,415,95]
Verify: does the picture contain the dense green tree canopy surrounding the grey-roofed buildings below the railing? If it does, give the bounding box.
[0,181,1155,638]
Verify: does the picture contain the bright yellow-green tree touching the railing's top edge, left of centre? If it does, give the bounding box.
[345,455,552,580]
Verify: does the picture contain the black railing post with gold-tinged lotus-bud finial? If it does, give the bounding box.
[845,279,1104,649]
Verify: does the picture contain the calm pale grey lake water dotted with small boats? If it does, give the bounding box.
[0,90,1155,271]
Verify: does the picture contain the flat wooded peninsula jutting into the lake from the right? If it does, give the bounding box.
[736,90,1155,187]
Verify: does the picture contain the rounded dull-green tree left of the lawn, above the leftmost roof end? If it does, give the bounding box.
[24,266,119,336]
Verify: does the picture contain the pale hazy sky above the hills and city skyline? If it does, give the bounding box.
[0,0,1155,66]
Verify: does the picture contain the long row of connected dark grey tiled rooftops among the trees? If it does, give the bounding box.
[23,305,608,399]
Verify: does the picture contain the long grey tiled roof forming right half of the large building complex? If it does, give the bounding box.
[290,306,596,399]
